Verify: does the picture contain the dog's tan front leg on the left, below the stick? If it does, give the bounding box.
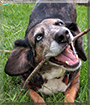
[29,89,45,105]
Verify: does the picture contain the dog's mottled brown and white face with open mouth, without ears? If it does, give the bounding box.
[27,19,81,71]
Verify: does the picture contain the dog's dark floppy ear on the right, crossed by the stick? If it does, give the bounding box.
[65,22,87,61]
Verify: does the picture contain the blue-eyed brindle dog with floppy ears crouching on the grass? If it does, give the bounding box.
[5,2,87,103]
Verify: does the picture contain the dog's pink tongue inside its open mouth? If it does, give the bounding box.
[55,45,77,65]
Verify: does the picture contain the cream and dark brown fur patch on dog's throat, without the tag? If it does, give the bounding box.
[39,62,66,79]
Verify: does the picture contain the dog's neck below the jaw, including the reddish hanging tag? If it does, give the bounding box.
[39,62,80,84]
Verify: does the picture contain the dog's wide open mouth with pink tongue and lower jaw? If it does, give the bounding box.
[50,45,80,69]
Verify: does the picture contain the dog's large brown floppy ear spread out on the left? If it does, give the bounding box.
[5,39,35,76]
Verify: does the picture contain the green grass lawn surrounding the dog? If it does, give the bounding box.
[0,3,88,103]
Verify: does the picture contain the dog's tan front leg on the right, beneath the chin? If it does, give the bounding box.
[64,70,80,103]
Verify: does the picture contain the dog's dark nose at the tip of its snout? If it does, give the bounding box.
[55,28,70,44]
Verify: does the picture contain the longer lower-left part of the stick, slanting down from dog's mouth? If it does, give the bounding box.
[16,58,48,101]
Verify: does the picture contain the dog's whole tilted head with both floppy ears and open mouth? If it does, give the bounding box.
[5,19,86,75]
